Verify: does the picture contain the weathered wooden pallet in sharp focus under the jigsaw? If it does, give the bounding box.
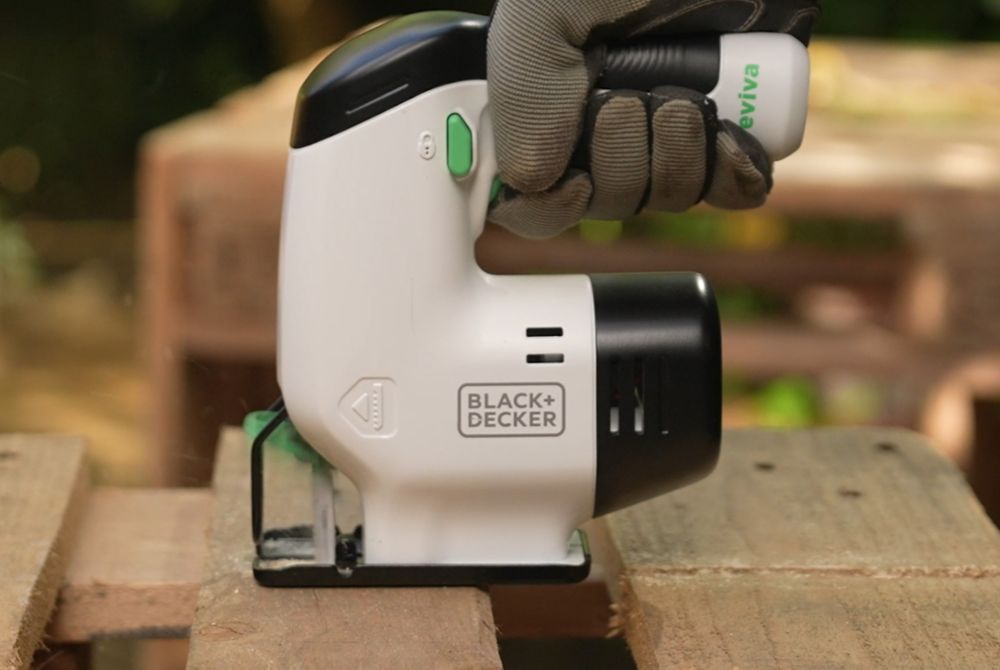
[7,429,1000,669]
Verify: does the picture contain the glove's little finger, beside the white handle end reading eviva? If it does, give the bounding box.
[705,121,773,209]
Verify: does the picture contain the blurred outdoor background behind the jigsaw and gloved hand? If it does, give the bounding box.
[0,0,1000,520]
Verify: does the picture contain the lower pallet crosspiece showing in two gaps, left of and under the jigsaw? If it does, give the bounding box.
[46,487,611,645]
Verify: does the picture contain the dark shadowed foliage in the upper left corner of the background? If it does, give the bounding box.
[0,0,274,217]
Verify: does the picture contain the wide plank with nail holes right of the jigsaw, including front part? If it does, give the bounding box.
[605,429,1000,668]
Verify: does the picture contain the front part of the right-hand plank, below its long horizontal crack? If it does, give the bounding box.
[624,573,1000,670]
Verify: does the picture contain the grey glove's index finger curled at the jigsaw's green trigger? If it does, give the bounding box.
[486,170,593,239]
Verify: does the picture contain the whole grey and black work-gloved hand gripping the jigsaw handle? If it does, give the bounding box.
[487,0,819,238]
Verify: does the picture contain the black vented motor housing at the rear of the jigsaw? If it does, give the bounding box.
[590,272,722,516]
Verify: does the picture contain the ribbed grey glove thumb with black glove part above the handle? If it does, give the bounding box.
[486,0,819,197]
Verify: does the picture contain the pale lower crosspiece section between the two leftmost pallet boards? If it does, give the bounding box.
[48,488,212,642]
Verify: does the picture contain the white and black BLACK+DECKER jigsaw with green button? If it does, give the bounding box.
[251,12,809,586]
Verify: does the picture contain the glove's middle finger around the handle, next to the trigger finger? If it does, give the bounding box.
[586,91,649,219]
